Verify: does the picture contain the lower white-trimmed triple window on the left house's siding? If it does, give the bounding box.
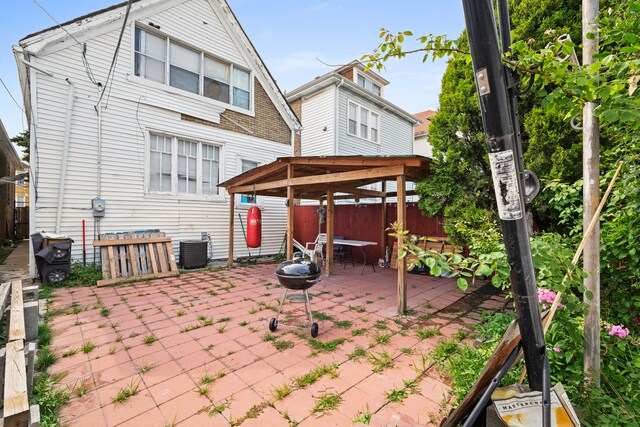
[148,133,220,196]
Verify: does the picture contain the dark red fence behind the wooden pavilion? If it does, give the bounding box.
[293,203,446,258]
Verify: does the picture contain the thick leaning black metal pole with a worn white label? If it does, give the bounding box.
[462,0,545,391]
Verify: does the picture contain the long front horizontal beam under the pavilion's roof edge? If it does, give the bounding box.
[232,165,405,193]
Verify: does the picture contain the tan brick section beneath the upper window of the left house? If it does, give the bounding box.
[180,79,291,145]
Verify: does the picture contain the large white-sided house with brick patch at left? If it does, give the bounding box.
[14,0,299,274]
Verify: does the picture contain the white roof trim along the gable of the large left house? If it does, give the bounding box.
[14,0,301,129]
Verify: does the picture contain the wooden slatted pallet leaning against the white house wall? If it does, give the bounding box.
[93,232,178,286]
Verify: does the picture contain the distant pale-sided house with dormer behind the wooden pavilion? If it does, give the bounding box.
[287,61,420,202]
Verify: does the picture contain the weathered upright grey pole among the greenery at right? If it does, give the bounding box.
[582,0,600,387]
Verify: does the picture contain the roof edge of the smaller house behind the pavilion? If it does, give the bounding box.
[287,70,419,125]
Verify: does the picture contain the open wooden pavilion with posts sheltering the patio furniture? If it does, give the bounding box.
[219,156,430,314]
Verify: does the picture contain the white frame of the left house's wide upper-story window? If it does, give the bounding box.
[131,22,255,114]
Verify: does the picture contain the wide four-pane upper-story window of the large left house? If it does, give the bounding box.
[134,27,252,110]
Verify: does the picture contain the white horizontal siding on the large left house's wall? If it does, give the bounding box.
[25,0,291,268]
